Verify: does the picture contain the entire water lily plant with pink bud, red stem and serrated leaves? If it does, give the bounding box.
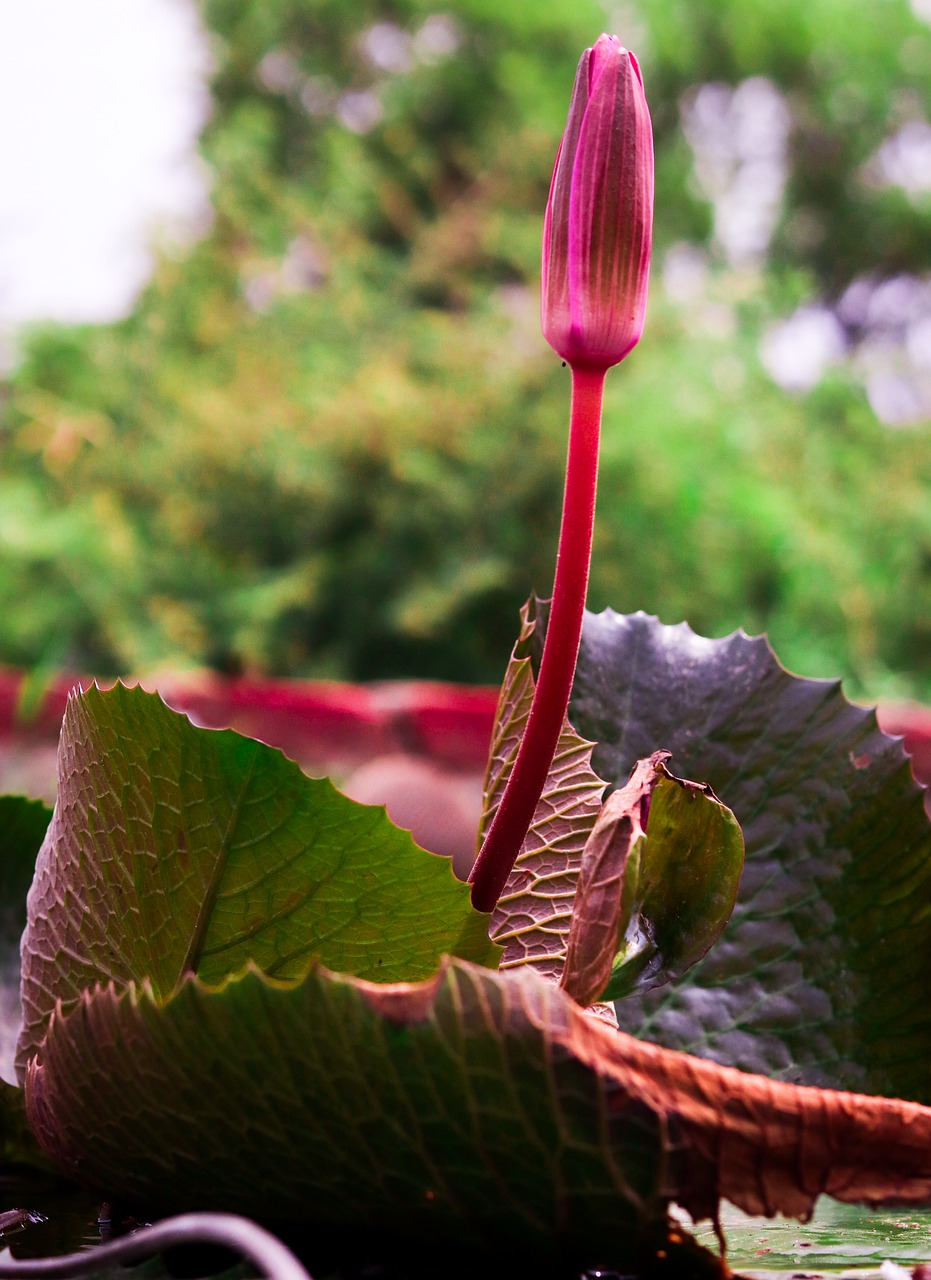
[0,27,931,1274]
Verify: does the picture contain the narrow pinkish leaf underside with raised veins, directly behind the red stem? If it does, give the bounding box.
[479,600,604,982]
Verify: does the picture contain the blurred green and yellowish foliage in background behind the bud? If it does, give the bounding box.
[0,0,931,698]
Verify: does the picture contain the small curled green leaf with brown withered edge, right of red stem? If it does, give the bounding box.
[560,751,744,1005]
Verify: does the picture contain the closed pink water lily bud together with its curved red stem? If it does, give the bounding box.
[471,36,653,911]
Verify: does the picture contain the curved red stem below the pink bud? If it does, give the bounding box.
[470,369,606,911]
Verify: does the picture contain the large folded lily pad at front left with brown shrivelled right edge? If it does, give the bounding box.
[14,645,931,1244]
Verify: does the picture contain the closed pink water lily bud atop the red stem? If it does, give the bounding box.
[543,36,653,370]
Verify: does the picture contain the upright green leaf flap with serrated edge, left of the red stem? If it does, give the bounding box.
[18,686,496,1071]
